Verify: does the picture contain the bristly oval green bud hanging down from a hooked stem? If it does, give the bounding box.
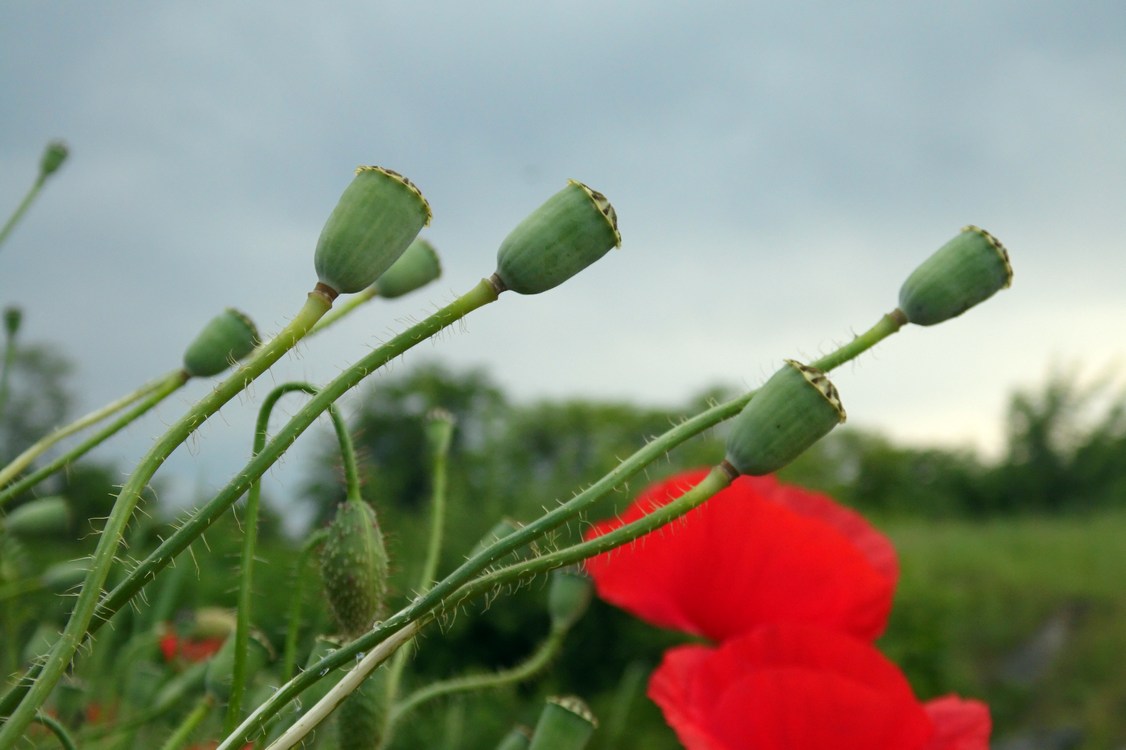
[321,500,387,635]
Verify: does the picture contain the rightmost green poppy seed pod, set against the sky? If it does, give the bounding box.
[900,226,1012,325]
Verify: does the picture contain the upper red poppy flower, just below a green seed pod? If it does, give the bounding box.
[587,471,899,641]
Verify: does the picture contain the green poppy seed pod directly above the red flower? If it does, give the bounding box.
[726,359,846,475]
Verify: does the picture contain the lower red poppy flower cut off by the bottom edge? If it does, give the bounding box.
[649,625,989,750]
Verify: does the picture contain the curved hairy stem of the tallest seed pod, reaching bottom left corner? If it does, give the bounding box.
[0,288,332,748]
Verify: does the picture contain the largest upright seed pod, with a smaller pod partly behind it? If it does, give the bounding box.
[313,167,430,294]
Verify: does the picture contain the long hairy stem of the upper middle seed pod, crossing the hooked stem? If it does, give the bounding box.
[0,274,498,725]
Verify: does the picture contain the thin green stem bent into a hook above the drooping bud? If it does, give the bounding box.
[223,383,359,732]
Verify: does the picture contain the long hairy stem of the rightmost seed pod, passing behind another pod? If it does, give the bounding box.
[218,312,902,750]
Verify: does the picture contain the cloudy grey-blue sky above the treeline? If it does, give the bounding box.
[0,0,1126,511]
